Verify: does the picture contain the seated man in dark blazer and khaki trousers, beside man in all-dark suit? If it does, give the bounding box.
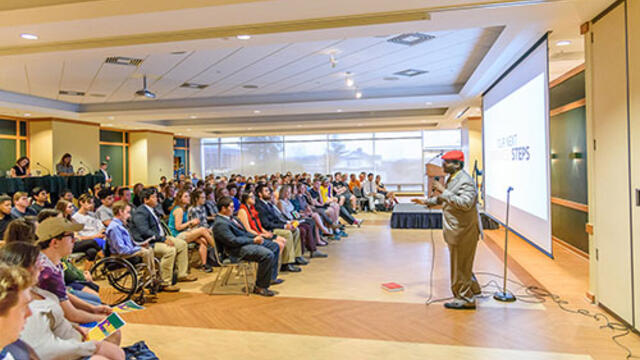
[254,184,309,272]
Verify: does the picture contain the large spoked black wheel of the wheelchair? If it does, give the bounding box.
[91,257,138,305]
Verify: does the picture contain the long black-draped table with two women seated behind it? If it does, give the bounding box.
[0,175,104,200]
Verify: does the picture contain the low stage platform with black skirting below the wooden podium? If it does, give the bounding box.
[391,203,442,229]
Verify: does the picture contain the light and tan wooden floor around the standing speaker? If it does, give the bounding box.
[123,214,640,360]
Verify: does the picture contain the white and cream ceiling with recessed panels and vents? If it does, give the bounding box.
[0,0,610,137]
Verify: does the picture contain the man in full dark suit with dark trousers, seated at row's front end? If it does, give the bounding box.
[213,197,278,296]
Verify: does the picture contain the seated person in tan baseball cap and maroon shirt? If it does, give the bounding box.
[36,217,111,324]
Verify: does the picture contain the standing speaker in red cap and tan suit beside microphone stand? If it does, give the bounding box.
[412,151,482,309]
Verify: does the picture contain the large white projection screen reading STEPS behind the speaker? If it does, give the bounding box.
[483,37,551,254]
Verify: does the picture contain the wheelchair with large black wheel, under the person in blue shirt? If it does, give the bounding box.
[90,242,160,306]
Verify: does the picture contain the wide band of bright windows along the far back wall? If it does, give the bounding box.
[202,130,461,189]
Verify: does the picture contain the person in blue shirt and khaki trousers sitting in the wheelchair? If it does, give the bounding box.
[106,200,156,278]
